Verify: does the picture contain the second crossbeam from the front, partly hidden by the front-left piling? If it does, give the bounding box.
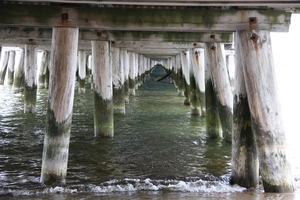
[0,27,233,43]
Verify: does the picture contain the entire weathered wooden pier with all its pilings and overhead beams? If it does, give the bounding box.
[0,0,300,192]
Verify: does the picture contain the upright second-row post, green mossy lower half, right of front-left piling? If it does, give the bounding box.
[92,41,114,137]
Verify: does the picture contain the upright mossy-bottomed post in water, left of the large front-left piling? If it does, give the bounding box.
[24,44,38,113]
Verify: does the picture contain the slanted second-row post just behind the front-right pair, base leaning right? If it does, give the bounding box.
[205,43,233,142]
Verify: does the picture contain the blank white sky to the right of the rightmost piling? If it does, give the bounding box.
[271,14,300,144]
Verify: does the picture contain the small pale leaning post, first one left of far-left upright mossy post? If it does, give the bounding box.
[12,50,25,93]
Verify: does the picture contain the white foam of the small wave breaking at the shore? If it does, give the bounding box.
[0,178,246,196]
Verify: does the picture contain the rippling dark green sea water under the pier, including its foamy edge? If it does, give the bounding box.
[0,66,298,199]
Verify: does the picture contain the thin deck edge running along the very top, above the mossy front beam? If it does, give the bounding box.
[4,0,300,7]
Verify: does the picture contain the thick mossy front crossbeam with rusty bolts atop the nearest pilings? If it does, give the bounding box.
[0,3,291,32]
